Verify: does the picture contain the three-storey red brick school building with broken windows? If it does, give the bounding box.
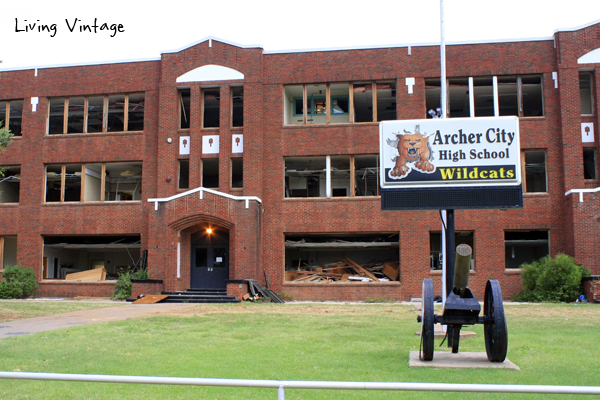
[0,21,600,300]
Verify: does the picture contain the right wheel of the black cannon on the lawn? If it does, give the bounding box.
[483,279,508,362]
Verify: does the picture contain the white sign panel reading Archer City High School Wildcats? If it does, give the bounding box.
[379,117,521,189]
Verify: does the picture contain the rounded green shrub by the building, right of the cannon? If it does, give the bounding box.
[513,254,587,302]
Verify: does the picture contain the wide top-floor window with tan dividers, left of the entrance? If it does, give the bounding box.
[48,93,145,135]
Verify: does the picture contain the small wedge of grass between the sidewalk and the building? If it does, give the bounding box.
[0,300,125,323]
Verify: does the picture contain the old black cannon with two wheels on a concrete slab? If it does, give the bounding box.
[417,244,508,362]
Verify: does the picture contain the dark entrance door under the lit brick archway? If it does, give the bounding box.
[190,230,229,289]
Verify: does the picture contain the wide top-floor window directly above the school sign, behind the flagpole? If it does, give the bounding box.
[425,75,544,118]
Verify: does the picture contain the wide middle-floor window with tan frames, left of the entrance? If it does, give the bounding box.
[45,162,142,203]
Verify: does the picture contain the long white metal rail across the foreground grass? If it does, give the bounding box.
[0,372,600,400]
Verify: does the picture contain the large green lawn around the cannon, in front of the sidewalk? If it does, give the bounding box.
[0,304,600,400]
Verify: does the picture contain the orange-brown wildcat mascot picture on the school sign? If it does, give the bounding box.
[386,125,435,179]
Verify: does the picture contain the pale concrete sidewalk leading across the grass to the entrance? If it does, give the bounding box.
[0,303,196,339]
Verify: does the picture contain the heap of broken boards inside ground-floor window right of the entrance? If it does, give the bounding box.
[285,257,400,282]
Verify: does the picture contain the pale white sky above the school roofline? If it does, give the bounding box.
[0,0,600,70]
